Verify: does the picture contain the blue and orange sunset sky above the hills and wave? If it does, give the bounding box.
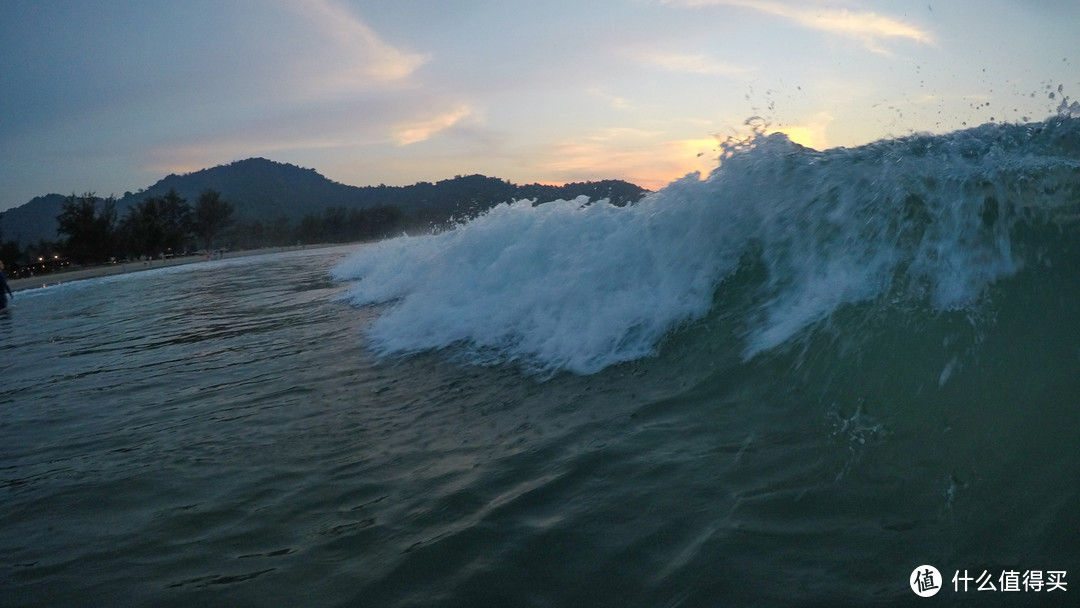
[0,0,1080,211]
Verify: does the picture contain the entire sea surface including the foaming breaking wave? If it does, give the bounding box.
[0,117,1080,608]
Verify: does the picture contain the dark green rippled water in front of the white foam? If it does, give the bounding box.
[0,247,1080,606]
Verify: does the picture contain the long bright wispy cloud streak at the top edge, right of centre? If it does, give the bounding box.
[664,0,933,54]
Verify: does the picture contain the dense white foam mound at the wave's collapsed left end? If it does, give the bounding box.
[334,178,737,374]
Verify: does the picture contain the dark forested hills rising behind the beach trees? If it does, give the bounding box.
[0,159,646,246]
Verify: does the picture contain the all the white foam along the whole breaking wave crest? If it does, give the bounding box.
[333,117,1080,374]
